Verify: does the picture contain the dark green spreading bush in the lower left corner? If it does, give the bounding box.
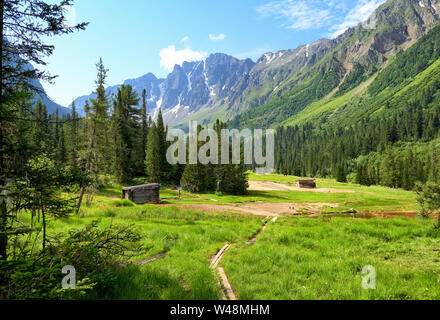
[0,222,142,300]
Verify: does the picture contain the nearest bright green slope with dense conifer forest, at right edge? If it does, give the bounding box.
[277,26,440,189]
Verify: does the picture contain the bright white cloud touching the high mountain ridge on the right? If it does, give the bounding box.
[330,0,386,38]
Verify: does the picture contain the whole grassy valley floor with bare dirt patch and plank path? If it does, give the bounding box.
[36,174,440,299]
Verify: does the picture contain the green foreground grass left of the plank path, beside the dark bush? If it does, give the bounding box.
[30,196,263,300]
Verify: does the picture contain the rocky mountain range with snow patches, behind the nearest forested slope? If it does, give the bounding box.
[65,0,440,128]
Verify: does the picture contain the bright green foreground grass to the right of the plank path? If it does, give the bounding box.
[221,218,440,300]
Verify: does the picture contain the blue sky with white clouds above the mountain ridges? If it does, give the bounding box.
[37,0,385,106]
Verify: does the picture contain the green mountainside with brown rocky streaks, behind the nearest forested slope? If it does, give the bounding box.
[231,0,440,127]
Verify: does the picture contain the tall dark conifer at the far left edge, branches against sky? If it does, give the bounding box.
[0,0,87,260]
